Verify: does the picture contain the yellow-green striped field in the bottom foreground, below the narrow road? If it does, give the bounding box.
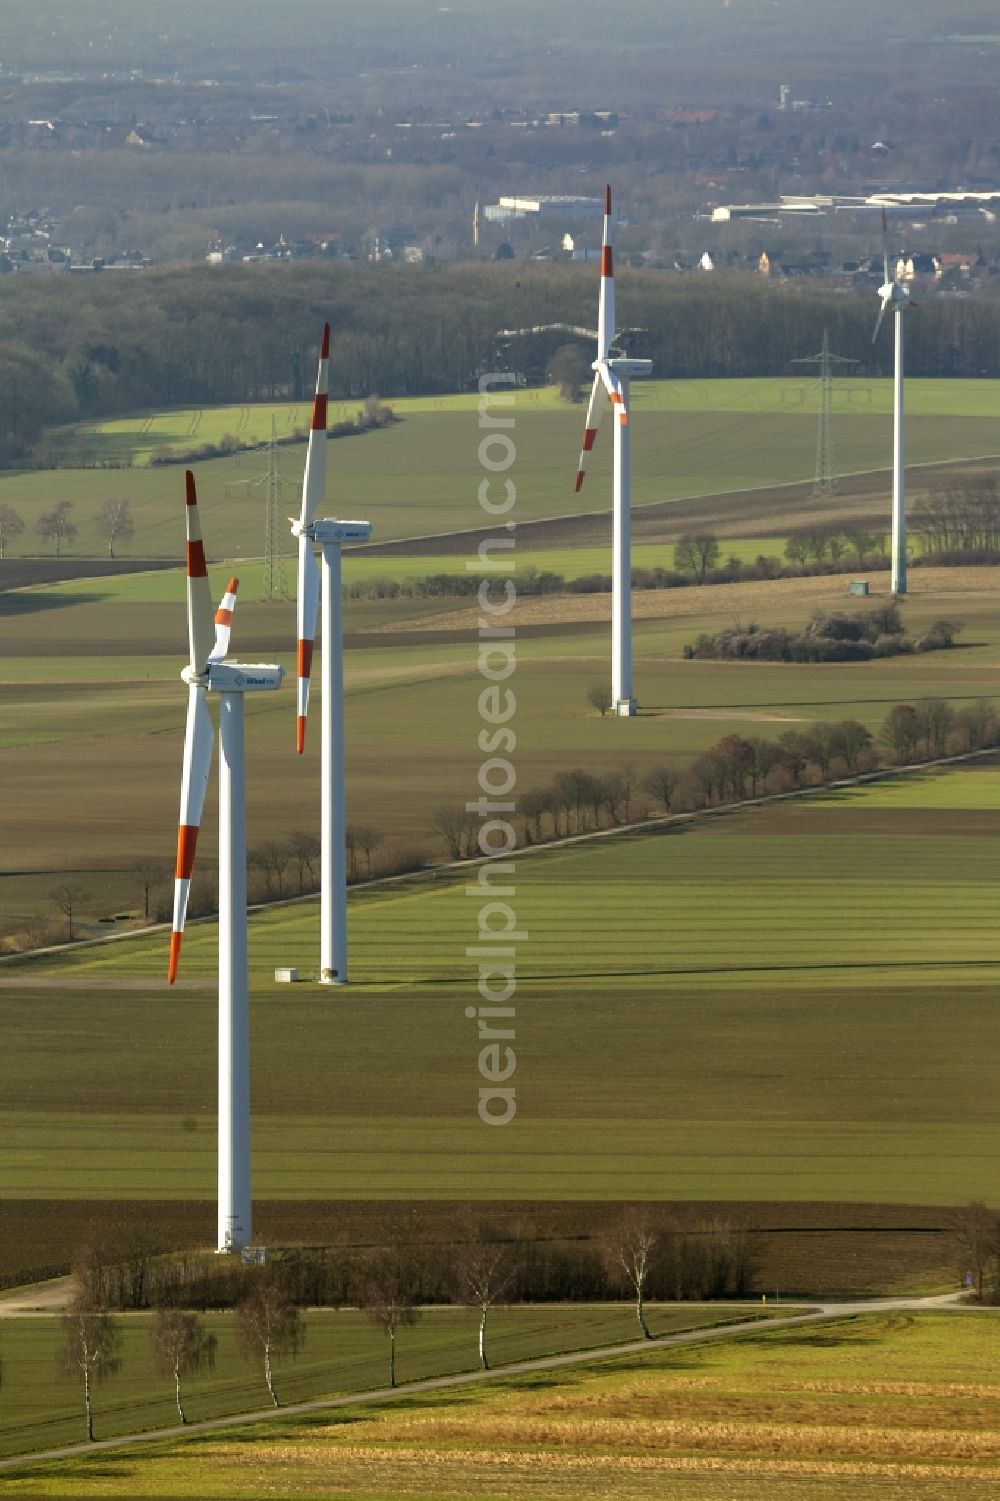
[5,1313,1000,1501]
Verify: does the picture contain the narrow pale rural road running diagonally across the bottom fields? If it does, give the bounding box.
[0,1292,991,1472]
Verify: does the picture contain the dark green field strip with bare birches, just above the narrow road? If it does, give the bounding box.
[0,1303,744,1458]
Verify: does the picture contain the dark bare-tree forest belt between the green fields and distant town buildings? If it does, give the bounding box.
[0,263,1000,467]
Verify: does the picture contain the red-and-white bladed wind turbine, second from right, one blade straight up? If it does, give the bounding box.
[577,188,653,717]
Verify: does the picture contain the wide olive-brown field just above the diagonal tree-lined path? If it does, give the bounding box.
[0,560,1000,925]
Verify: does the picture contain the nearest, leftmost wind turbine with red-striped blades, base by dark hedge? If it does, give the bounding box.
[168,471,285,1250]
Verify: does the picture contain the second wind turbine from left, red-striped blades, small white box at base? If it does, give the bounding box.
[290,323,371,985]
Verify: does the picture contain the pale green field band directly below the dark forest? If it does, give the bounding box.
[0,381,998,557]
